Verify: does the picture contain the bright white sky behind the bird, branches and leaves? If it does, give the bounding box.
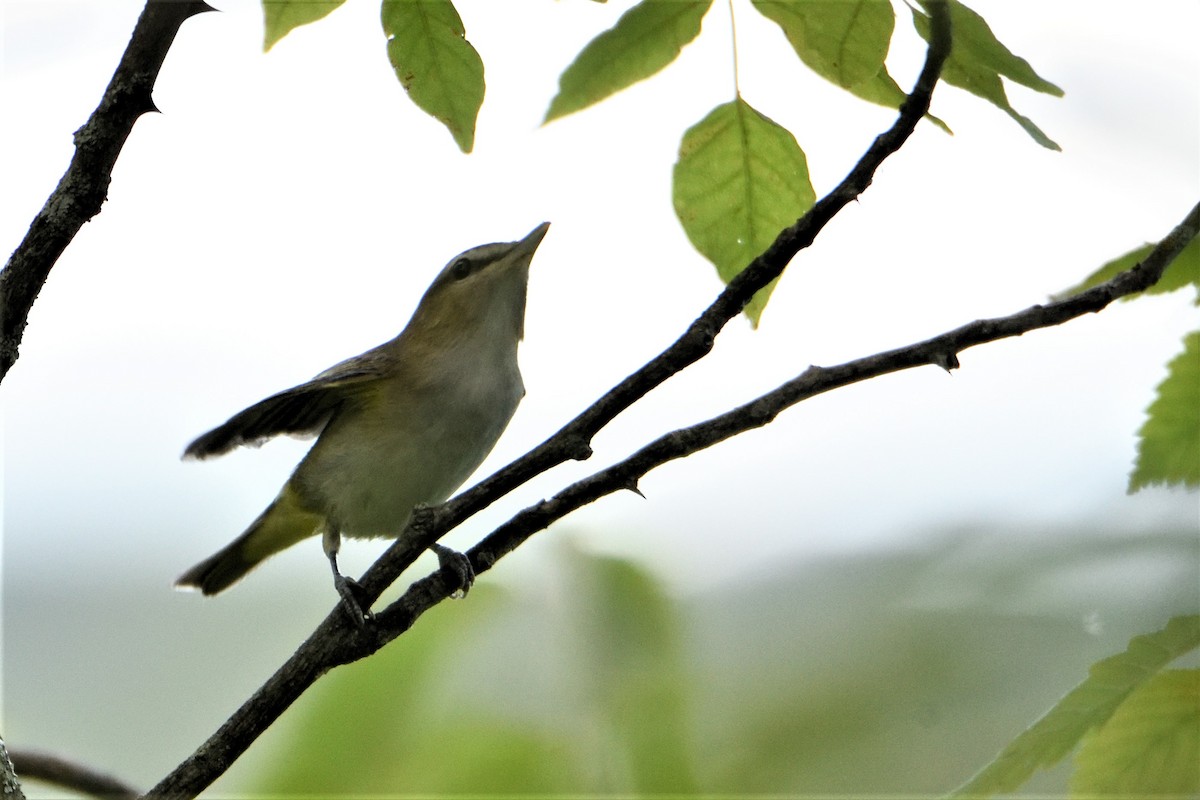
[0,0,1200,602]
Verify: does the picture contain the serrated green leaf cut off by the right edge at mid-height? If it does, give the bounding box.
[1129,331,1200,492]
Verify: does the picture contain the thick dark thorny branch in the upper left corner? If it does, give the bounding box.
[0,0,211,381]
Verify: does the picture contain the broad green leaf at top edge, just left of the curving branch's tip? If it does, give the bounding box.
[752,0,895,89]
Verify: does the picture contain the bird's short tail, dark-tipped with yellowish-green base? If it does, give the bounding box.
[175,483,324,595]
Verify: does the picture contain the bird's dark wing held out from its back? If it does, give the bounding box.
[184,353,382,458]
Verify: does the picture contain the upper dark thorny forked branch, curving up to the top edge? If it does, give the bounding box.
[148,7,950,798]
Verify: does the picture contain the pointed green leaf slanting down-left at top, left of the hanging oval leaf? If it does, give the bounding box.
[542,0,713,122]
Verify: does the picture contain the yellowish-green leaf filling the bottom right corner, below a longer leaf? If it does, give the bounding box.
[1070,669,1200,798]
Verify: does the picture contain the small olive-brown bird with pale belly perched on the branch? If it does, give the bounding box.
[175,222,550,625]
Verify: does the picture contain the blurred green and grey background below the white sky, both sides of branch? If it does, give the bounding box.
[5,515,1200,798]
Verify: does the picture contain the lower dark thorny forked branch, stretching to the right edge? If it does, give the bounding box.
[151,183,1200,798]
